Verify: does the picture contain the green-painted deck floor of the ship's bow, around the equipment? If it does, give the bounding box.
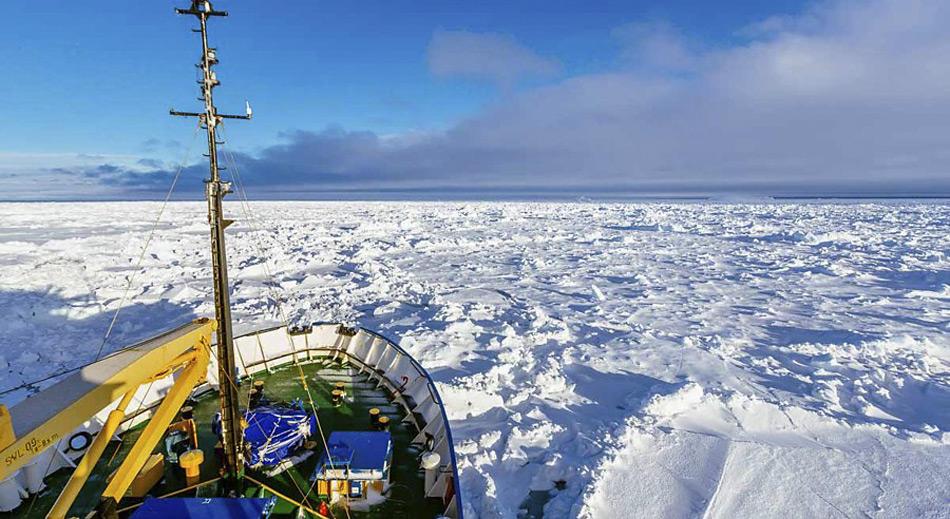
[0,362,443,518]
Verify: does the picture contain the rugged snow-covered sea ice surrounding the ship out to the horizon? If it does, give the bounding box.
[0,202,950,519]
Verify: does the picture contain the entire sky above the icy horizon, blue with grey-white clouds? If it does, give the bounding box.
[0,0,950,198]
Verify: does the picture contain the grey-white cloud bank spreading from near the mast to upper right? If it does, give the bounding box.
[13,0,950,199]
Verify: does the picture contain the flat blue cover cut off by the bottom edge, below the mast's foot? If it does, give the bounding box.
[132,497,277,519]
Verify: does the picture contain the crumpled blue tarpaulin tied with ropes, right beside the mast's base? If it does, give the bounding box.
[244,405,317,467]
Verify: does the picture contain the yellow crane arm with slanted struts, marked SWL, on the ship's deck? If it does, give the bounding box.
[0,319,217,519]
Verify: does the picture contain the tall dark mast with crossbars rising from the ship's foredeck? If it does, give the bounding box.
[170,0,251,489]
